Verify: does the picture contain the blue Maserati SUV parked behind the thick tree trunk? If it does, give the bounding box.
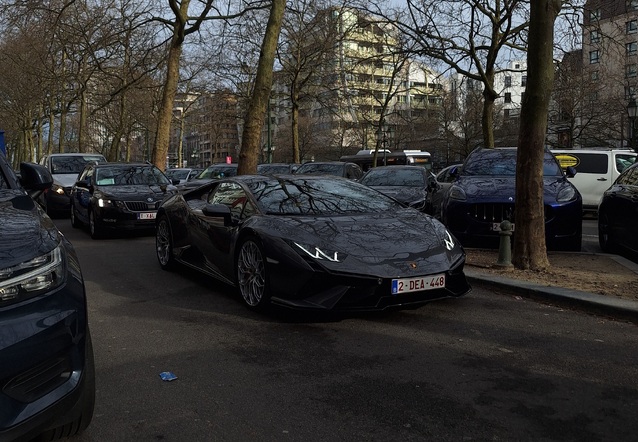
[441,148,583,251]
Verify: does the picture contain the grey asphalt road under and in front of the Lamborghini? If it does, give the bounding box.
[52,219,638,441]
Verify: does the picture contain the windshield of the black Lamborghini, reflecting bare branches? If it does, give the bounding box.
[249,178,401,215]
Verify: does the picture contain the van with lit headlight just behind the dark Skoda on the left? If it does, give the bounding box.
[38,153,106,217]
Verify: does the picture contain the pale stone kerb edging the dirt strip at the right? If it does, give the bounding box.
[465,254,638,324]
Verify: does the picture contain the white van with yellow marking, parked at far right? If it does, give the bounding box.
[552,148,638,211]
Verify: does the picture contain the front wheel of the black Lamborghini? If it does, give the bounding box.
[235,236,270,310]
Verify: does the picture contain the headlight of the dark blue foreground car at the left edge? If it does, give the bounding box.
[0,244,66,305]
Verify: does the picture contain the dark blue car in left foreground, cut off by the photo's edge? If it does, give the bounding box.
[0,153,95,441]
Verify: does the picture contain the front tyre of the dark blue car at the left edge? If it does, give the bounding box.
[32,328,95,442]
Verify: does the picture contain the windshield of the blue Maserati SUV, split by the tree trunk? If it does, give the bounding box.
[462,149,563,176]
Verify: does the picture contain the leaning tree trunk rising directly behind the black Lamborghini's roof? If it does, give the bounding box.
[237,0,286,175]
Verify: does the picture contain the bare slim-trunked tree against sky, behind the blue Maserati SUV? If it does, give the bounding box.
[375,0,529,147]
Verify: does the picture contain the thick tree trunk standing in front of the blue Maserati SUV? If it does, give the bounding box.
[512,0,562,270]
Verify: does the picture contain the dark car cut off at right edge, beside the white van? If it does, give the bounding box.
[598,163,638,253]
